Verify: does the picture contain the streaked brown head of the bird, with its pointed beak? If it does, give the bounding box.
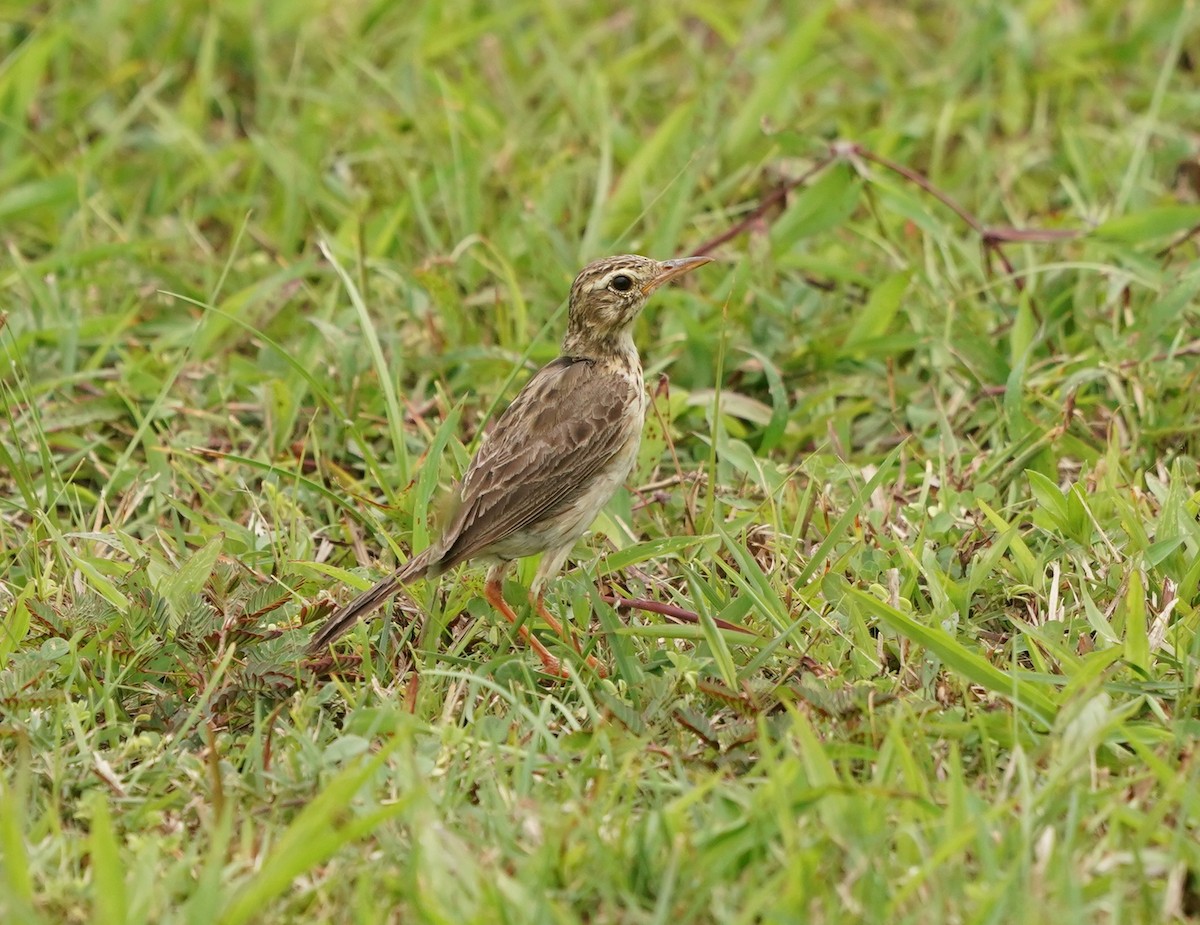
[563,254,713,356]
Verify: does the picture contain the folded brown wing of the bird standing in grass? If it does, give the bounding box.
[438,356,643,571]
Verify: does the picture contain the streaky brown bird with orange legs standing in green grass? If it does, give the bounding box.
[308,254,713,677]
